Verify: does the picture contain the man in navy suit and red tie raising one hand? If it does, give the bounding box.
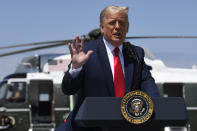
[57,6,159,131]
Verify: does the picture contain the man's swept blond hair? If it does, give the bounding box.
[100,6,129,25]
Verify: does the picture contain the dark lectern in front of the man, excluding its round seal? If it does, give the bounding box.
[75,97,188,131]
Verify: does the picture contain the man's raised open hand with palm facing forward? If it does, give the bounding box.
[68,35,93,69]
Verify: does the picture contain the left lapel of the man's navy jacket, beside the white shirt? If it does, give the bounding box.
[97,37,114,96]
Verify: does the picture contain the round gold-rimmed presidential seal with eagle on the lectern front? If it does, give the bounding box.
[121,90,153,124]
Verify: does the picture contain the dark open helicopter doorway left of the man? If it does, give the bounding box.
[28,80,53,124]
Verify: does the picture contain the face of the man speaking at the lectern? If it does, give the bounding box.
[100,11,129,47]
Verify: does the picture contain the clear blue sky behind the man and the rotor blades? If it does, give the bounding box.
[0,0,197,79]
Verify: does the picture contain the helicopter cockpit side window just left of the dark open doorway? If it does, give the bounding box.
[6,82,26,102]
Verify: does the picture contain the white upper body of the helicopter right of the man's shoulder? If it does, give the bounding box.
[145,58,197,83]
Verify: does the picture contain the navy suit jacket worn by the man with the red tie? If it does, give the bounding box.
[62,36,159,130]
